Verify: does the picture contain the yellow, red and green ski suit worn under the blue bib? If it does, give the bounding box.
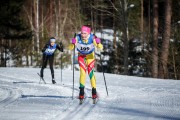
[69,33,103,88]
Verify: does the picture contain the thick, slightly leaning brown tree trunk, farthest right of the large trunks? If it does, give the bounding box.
[159,0,172,79]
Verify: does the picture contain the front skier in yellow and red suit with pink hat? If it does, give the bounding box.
[69,26,103,99]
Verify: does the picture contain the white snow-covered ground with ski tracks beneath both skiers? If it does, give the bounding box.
[0,68,180,120]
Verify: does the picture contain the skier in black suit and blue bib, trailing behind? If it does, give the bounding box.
[40,37,63,84]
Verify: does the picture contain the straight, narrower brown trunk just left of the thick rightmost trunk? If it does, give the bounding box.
[152,0,158,78]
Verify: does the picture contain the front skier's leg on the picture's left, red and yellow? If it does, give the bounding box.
[78,55,86,99]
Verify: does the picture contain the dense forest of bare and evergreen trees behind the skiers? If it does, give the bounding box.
[0,0,180,80]
